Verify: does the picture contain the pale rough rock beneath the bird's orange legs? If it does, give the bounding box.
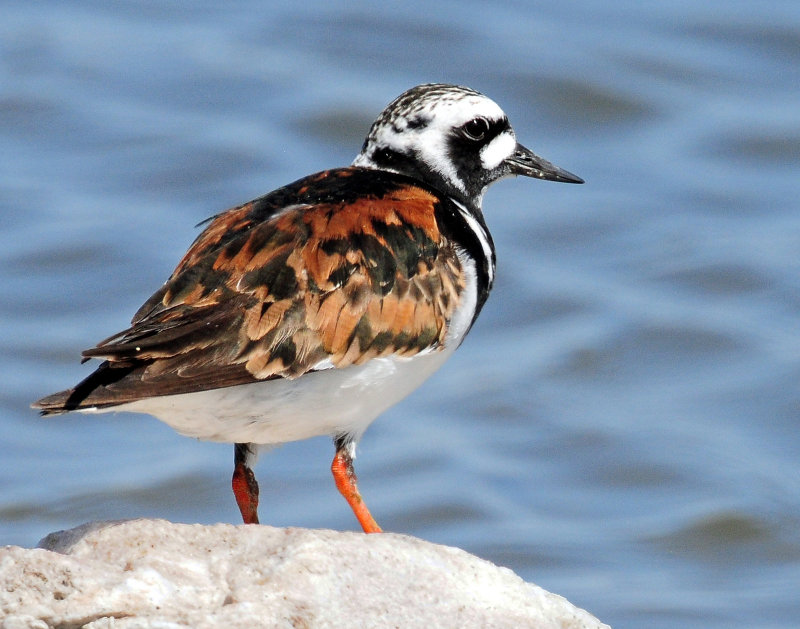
[0,520,607,629]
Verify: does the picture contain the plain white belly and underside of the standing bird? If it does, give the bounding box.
[87,257,477,445]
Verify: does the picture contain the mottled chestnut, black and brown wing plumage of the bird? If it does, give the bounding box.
[72,179,464,404]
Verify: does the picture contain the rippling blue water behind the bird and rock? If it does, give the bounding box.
[0,0,800,629]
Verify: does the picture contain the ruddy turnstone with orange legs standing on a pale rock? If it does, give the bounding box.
[32,83,583,533]
